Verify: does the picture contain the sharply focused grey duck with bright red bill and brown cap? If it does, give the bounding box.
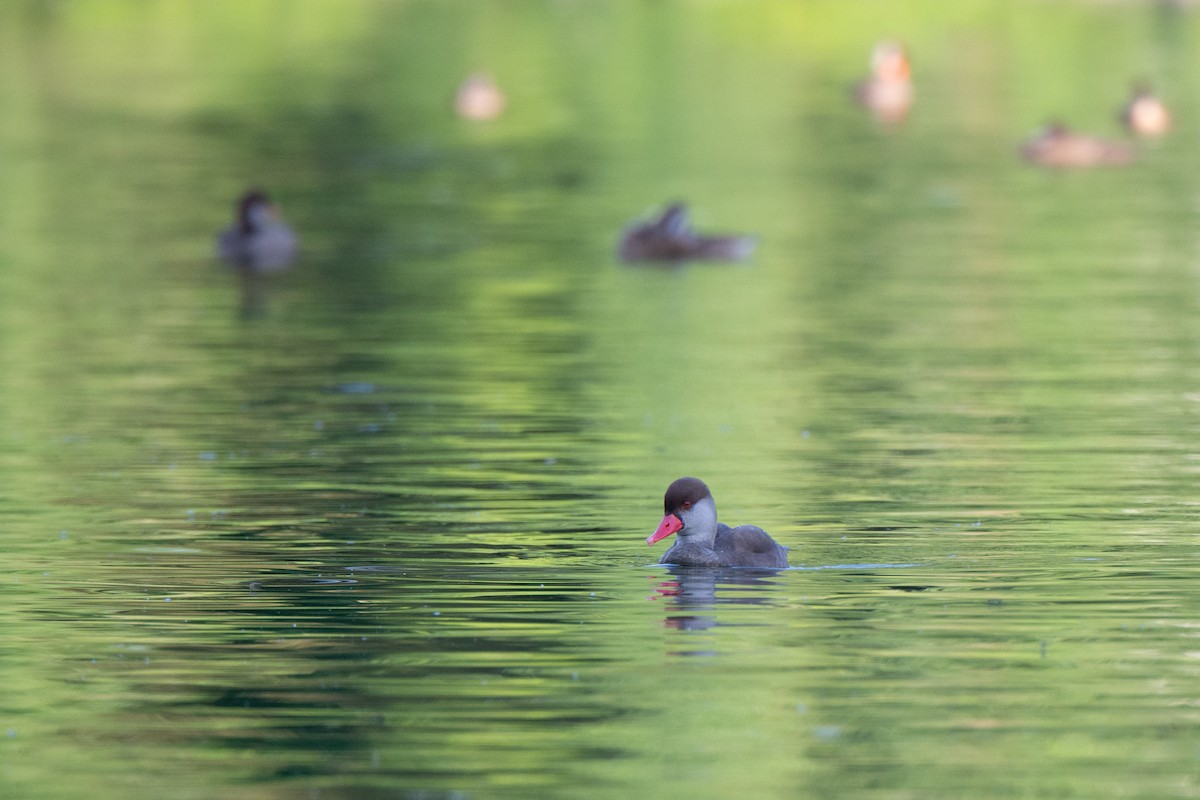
[646,477,788,570]
